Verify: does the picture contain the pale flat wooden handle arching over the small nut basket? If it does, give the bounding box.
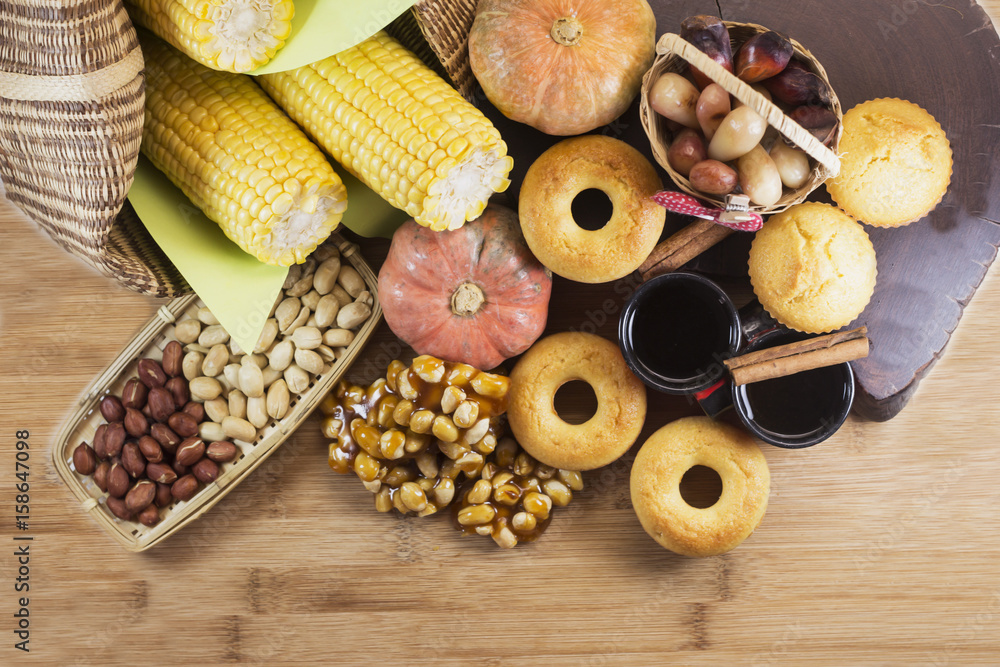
[656,33,840,177]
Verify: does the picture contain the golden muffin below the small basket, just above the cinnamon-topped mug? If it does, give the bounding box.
[750,202,877,333]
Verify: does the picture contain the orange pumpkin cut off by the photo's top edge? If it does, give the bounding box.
[469,0,656,136]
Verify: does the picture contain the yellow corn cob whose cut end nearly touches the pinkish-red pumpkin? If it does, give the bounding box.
[259,32,513,231]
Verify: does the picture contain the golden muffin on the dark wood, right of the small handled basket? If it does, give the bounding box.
[826,99,952,227]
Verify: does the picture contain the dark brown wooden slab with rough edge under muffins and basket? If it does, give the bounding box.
[448,0,1000,420]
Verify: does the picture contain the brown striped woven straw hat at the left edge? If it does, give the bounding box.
[0,0,190,297]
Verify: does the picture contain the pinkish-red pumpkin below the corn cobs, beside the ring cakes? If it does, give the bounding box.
[378,204,552,369]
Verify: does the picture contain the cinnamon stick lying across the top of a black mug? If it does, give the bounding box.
[724,327,869,386]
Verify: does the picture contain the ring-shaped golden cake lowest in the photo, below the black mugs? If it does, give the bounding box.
[629,417,771,557]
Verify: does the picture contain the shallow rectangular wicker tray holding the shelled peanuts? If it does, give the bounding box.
[52,234,382,551]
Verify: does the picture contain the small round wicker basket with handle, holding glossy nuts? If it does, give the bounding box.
[639,21,844,213]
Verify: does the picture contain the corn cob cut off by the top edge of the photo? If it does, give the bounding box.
[126,0,295,72]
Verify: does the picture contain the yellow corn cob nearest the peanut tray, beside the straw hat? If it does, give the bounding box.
[142,34,347,266]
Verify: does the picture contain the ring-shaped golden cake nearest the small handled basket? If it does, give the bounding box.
[518,135,667,283]
